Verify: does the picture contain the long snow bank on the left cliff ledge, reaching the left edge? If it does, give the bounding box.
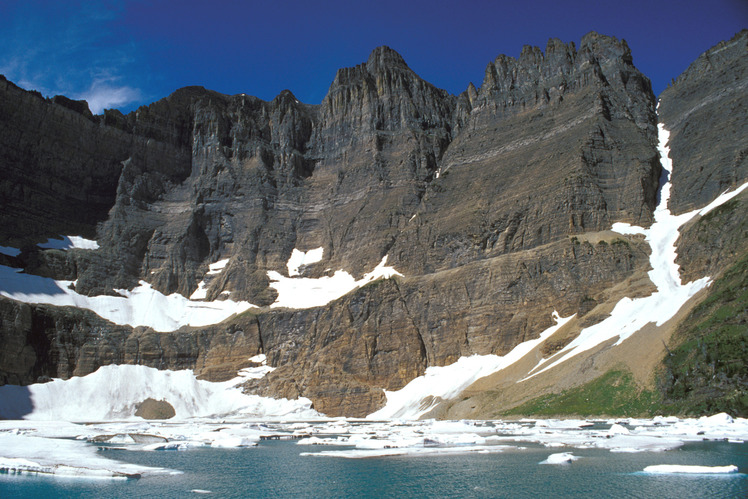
[0,265,254,332]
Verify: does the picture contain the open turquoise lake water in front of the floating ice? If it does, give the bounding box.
[0,441,748,499]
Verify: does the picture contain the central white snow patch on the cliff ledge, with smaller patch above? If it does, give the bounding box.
[268,256,402,309]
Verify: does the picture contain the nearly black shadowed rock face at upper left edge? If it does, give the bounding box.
[0,77,126,246]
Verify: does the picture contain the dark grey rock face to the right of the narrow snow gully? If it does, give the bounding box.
[659,30,748,213]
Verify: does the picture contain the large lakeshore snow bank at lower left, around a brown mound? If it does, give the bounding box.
[0,365,319,421]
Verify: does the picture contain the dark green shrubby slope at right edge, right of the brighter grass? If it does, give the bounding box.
[658,250,748,417]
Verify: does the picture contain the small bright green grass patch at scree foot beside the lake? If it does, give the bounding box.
[502,370,659,417]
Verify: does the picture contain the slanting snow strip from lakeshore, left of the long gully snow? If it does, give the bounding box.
[367,311,573,419]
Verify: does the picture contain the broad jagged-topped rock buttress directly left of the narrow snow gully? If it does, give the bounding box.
[392,33,660,273]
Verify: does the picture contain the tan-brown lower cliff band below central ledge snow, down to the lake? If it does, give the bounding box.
[248,236,648,416]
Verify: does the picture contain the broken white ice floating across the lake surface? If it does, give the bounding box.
[0,414,748,477]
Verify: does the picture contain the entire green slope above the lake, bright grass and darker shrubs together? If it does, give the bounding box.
[502,253,748,417]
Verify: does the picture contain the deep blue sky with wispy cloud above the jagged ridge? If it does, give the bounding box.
[0,0,748,112]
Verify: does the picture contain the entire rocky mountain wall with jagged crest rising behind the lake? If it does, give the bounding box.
[0,31,748,416]
